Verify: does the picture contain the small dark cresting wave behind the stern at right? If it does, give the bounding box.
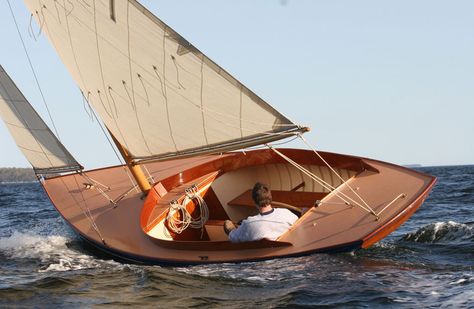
[402,221,474,243]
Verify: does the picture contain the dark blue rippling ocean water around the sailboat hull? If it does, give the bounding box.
[0,166,474,308]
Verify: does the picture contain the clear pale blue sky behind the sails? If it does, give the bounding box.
[0,0,474,168]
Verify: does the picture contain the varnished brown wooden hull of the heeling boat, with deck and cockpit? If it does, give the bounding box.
[43,149,435,265]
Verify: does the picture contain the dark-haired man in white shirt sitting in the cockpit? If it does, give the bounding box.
[224,182,298,242]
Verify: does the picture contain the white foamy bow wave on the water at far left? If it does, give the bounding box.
[0,231,118,272]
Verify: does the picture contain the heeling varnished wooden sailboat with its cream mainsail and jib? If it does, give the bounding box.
[0,0,435,264]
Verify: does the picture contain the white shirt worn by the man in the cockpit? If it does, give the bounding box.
[229,208,298,242]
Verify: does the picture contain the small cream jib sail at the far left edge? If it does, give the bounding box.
[0,66,82,174]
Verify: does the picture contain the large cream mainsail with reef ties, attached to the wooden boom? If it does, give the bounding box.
[25,0,302,161]
